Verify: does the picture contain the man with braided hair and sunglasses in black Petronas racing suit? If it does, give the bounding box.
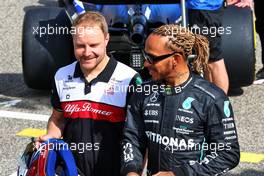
[121,24,240,176]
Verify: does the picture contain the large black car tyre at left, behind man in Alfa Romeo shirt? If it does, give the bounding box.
[22,7,74,89]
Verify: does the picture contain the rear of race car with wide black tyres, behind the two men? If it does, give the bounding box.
[22,0,255,89]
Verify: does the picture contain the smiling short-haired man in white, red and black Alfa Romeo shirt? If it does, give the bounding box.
[38,12,141,176]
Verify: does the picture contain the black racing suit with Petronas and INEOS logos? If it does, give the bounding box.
[121,75,240,176]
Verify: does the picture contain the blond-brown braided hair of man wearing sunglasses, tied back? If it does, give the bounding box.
[151,24,209,74]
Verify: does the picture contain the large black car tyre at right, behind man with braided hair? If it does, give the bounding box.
[222,6,256,88]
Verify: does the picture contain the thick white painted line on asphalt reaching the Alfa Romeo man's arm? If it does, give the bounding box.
[0,110,50,122]
